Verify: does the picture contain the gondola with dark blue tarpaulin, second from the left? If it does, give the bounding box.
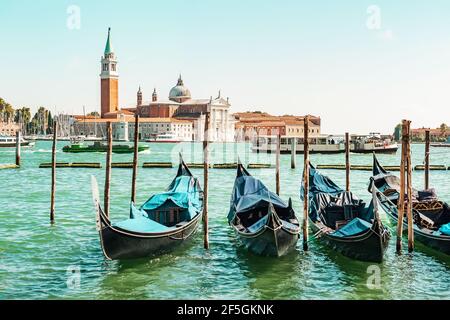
[228,163,300,257]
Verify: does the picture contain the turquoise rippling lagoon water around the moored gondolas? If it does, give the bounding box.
[0,142,450,299]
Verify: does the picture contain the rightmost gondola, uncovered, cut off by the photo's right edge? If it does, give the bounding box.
[371,155,450,255]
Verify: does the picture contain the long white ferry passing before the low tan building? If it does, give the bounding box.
[252,135,345,154]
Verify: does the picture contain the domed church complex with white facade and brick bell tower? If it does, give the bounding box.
[74,29,235,142]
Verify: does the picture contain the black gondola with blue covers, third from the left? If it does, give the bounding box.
[300,165,390,262]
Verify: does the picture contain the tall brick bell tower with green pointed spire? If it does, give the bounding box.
[100,28,119,118]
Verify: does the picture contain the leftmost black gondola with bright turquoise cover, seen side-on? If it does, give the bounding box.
[92,160,203,260]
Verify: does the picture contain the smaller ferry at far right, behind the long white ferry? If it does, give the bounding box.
[350,133,398,154]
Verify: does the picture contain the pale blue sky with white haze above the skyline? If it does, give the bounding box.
[0,0,450,134]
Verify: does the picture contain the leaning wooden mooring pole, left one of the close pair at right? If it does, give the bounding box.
[396,120,407,254]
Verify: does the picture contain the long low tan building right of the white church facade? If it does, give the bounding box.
[234,112,321,141]
